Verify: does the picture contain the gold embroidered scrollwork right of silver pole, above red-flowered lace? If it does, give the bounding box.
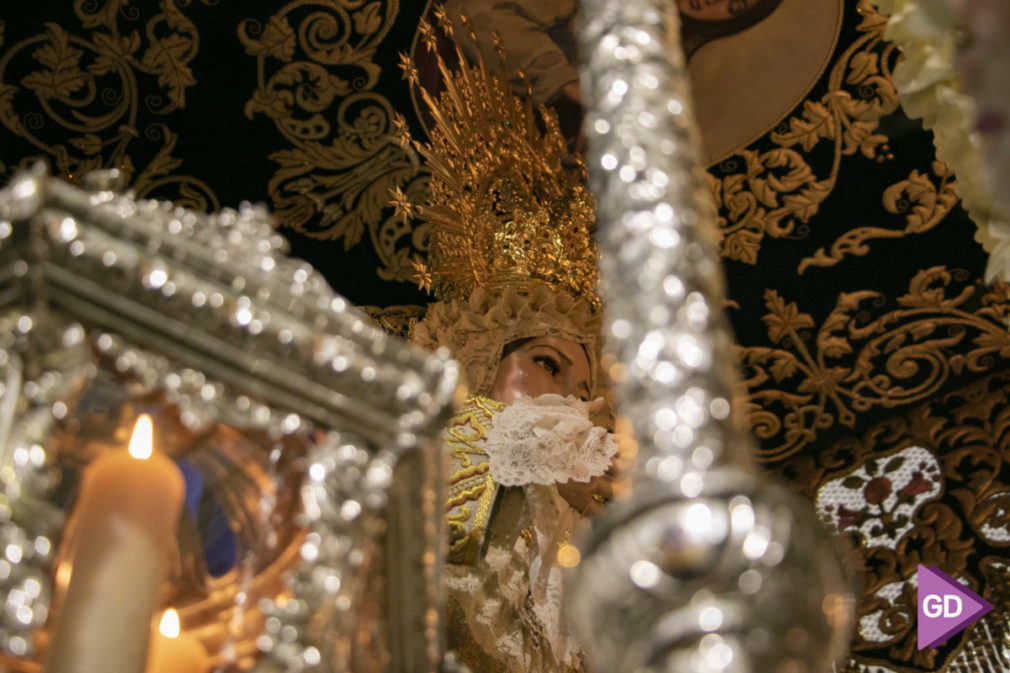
[737,267,1010,462]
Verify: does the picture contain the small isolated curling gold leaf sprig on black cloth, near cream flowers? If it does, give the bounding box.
[798,162,957,274]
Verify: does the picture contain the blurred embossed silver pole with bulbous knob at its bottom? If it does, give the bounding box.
[566,0,851,673]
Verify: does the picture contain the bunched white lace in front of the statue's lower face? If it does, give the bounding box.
[485,394,617,486]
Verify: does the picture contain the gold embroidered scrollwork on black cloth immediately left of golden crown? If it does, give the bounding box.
[238,0,423,281]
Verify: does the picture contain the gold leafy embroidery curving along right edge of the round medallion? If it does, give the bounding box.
[709,0,898,264]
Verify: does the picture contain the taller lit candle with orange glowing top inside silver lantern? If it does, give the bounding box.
[46,415,185,673]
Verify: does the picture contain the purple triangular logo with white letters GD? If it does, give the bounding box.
[918,565,993,650]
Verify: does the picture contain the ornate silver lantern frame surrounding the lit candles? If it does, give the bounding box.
[0,159,458,673]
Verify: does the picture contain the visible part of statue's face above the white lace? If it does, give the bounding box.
[488,337,590,404]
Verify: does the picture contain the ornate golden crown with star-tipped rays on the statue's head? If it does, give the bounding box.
[394,7,599,308]
